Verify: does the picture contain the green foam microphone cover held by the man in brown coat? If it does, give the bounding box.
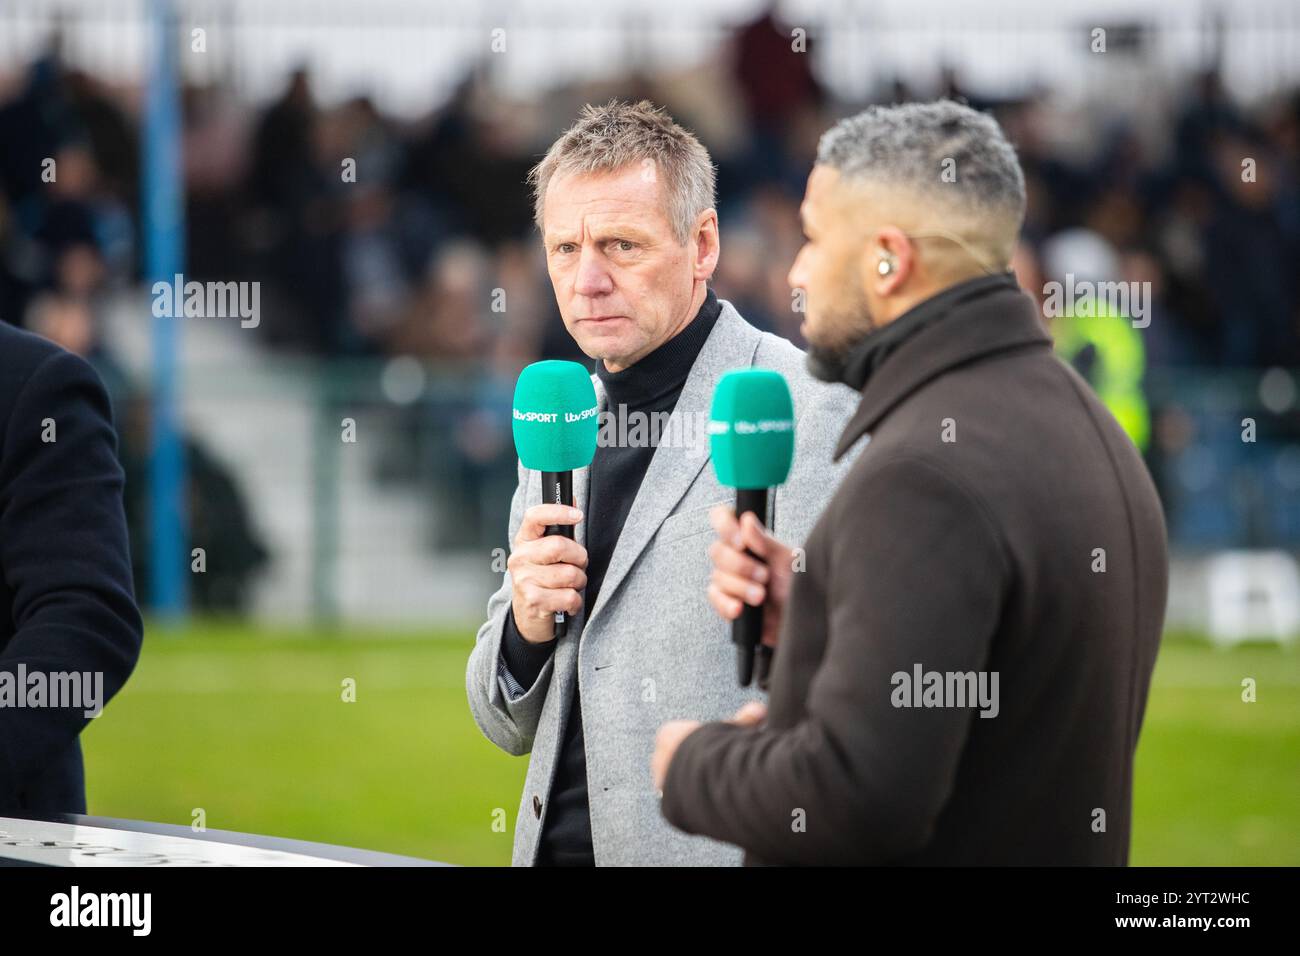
[709,368,794,489]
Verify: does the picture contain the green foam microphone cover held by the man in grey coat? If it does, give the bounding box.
[512,362,599,471]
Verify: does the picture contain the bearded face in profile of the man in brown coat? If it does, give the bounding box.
[787,165,872,352]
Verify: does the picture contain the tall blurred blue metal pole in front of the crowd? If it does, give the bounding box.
[140,0,189,619]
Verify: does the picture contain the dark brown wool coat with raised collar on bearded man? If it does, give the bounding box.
[662,282,1167,865]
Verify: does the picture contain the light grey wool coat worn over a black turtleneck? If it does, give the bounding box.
[465,300,857,866]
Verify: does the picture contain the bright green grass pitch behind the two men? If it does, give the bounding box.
[83,623,1300,865]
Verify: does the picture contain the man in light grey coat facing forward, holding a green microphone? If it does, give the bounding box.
[467,103,853,865]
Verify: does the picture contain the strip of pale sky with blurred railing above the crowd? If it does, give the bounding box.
[0,0,1300,116]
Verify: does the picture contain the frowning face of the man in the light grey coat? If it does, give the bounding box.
[542,165,716,372]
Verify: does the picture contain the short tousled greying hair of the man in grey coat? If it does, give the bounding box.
[528,100,718,243]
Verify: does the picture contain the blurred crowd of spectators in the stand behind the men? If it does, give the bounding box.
[0,17,1300,605]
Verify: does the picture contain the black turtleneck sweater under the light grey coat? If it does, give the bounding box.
[502,290,722,866]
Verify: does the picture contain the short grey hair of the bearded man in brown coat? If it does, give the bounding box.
[816,100,1024,230]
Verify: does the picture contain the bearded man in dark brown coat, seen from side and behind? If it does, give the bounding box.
[653,103,1167,865]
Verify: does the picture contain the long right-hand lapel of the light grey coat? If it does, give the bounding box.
[573,299,762,630]
